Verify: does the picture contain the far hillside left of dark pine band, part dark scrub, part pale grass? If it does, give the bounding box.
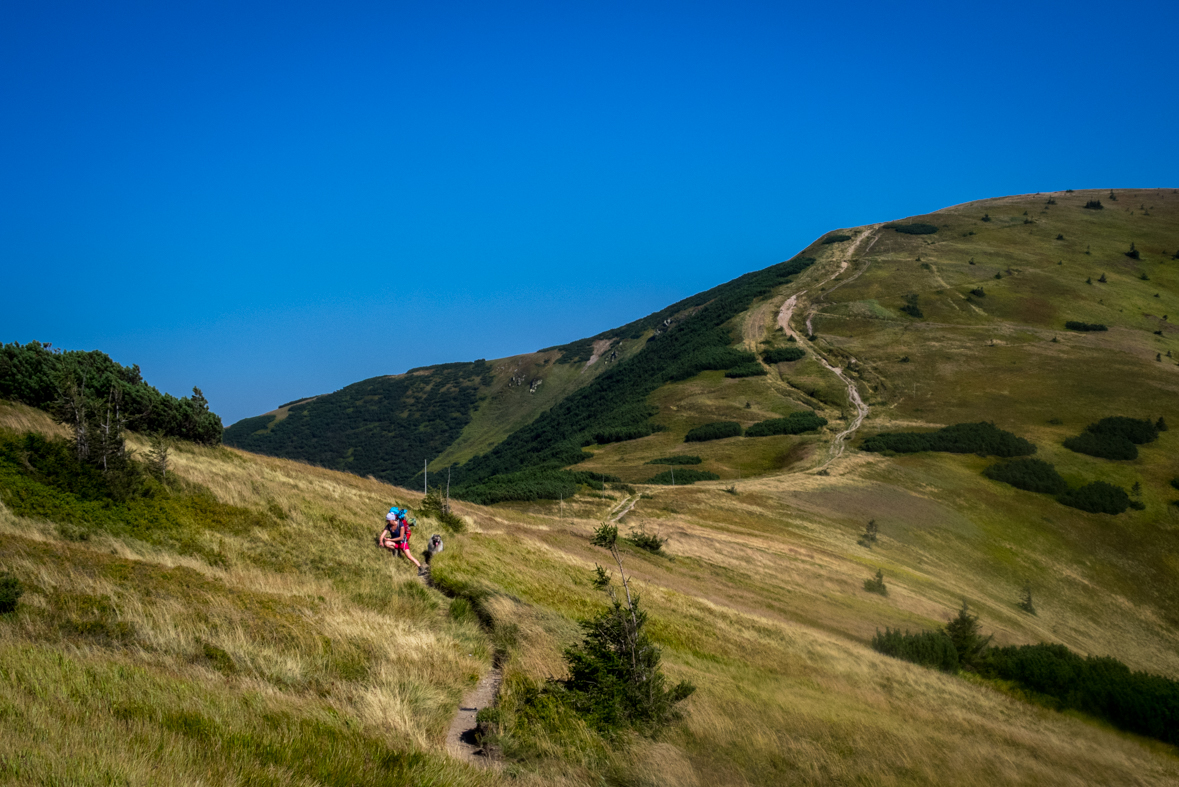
[224,252,815,485]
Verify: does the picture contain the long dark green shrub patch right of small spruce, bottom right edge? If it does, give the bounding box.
[980,643,1179,746]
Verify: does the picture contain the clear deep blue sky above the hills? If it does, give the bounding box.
[0,0,1179,424]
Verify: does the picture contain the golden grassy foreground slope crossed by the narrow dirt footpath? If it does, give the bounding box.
[0,393,1179,785]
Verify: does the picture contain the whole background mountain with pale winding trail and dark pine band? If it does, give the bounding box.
[226,190,1179,502]
